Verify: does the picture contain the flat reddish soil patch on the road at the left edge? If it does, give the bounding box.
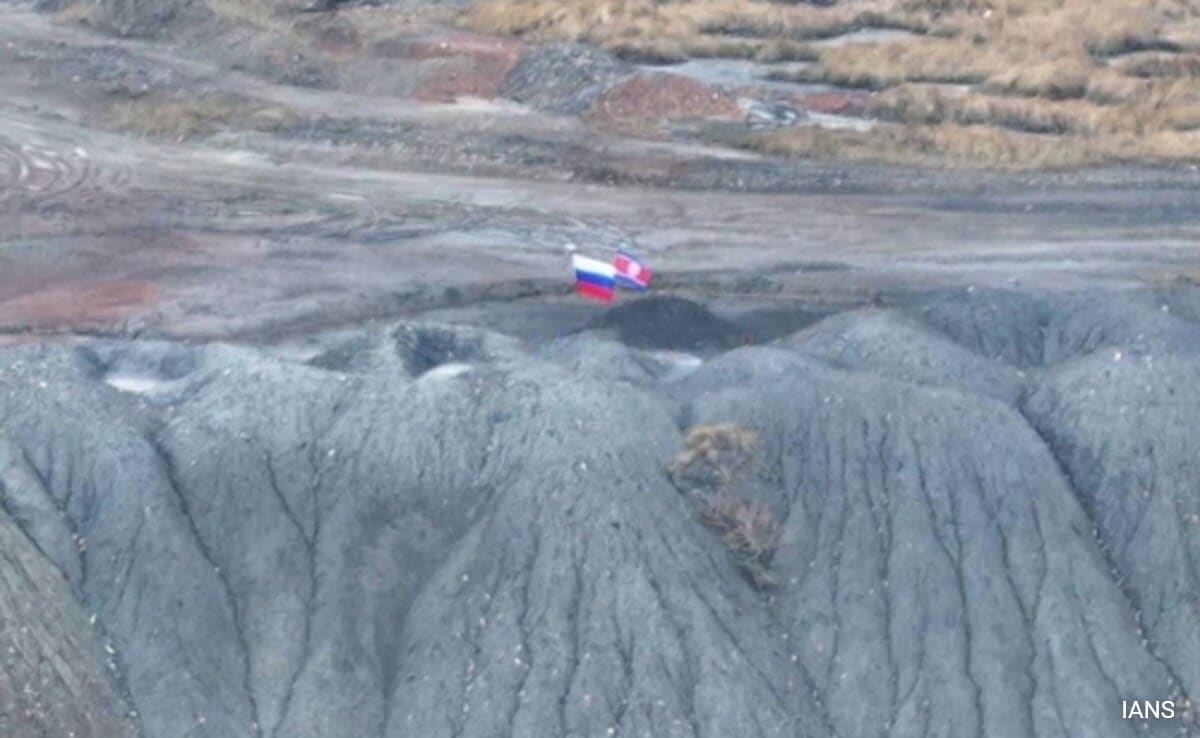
[0,280,158,330]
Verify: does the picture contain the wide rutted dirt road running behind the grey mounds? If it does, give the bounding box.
[0,4,1200,337]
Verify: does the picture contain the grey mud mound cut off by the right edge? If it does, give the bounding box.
[1027,352,1200,715]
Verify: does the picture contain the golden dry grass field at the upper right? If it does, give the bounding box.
[462,0,1200,168]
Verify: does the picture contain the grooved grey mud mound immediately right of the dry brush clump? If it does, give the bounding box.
[672,348,1180,737]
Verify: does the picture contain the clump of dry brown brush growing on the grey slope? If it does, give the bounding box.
[667,424,784,589]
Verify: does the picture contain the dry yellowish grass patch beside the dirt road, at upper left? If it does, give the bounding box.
[108,95,296,140]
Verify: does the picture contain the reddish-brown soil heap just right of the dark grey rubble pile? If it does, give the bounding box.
[587,73,739,130]
